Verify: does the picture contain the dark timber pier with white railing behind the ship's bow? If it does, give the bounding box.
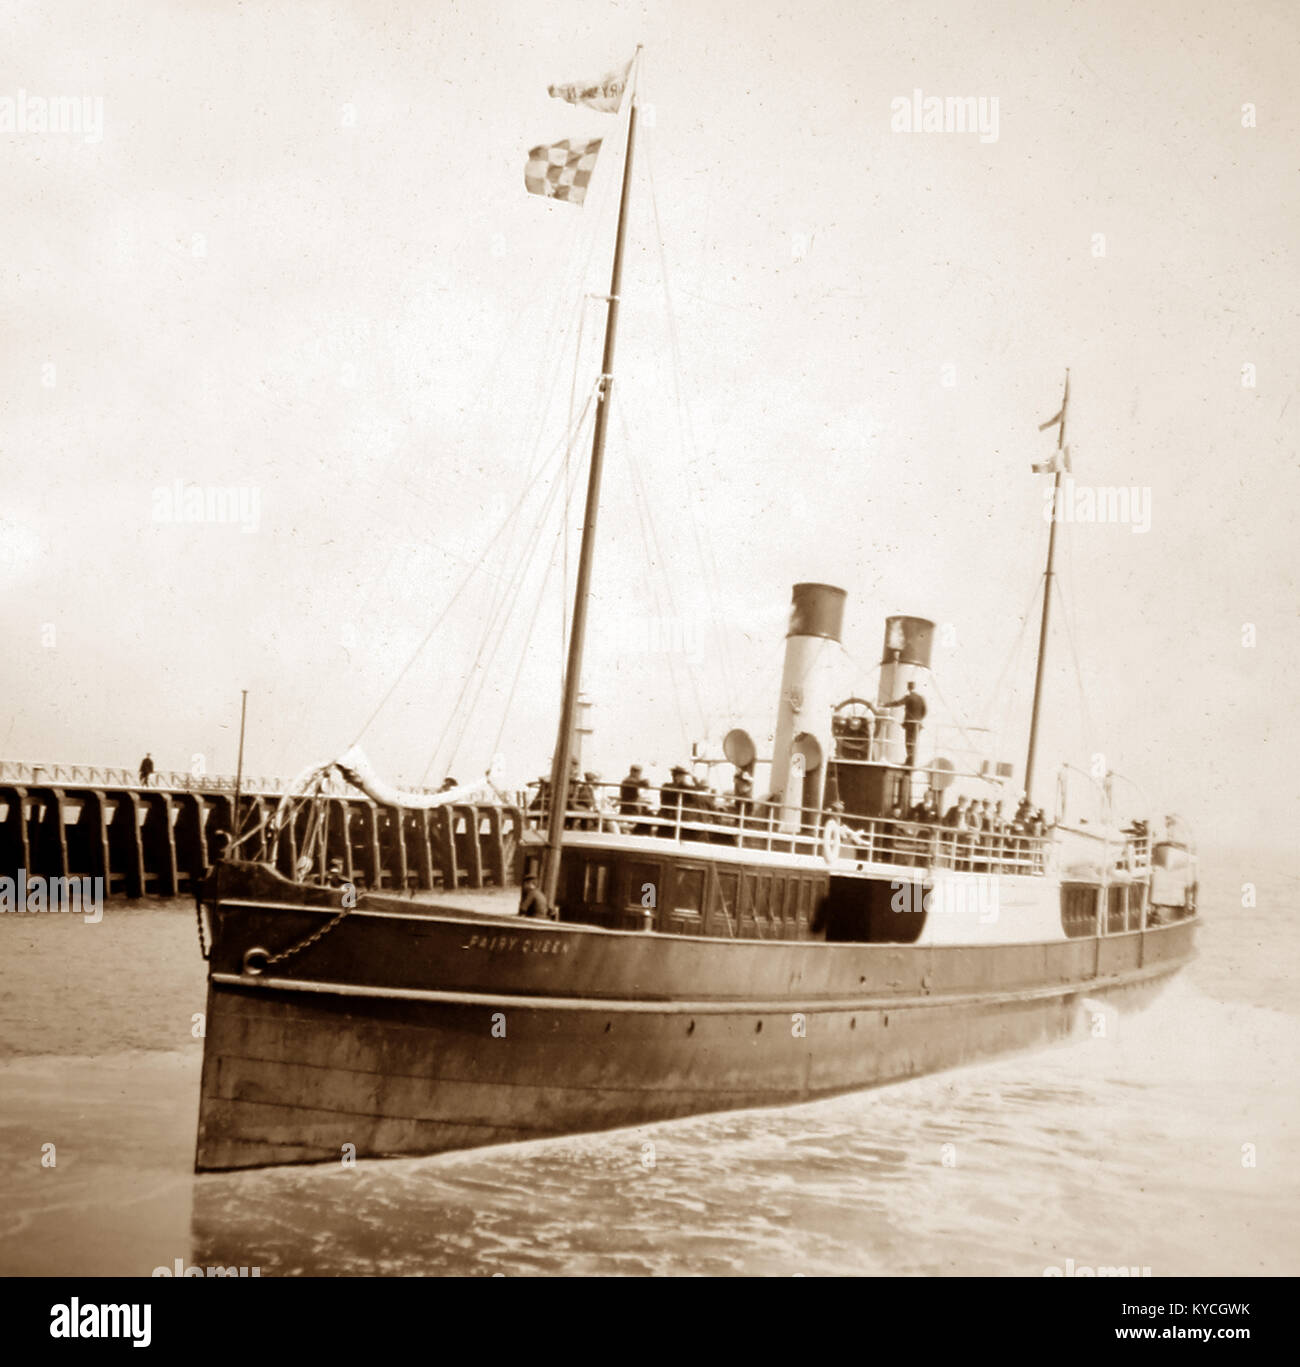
[0,761,525,898]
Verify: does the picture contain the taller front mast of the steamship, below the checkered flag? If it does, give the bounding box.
[541,58,641,905]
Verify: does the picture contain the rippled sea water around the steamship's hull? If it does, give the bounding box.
[0,856,1300,1277]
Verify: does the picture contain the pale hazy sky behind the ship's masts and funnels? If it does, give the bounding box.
[0,0,1300,845]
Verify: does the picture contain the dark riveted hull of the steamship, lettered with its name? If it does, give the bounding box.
[195,885,1195,1170]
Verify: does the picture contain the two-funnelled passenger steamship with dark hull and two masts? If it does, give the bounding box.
[188,58,1196,1170]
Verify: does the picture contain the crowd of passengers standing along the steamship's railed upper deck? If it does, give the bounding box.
[530,763,1047,868]
